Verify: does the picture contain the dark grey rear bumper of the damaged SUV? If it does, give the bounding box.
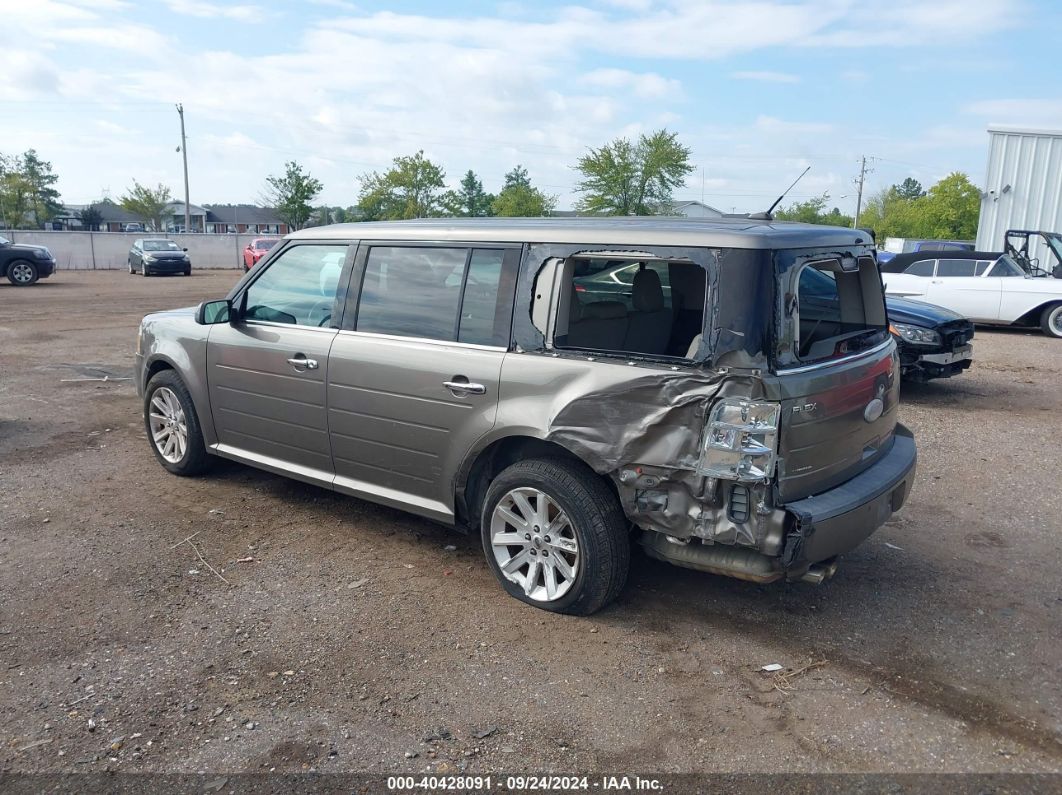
[783,425,918,569]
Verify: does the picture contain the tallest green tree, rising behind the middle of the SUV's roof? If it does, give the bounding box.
[576,129,693,215]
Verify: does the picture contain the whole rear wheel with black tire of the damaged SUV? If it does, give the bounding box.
[480,459,631,616]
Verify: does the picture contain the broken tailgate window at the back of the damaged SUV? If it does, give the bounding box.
[792,257,887,363]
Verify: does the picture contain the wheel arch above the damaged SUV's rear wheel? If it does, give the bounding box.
[453,433,619,532]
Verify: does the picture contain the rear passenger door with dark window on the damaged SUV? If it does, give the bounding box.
[328,242,519,521]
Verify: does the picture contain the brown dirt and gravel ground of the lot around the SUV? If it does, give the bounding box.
[0,271,1062,773]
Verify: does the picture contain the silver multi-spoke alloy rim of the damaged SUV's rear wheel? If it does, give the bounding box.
[491,487,579,602]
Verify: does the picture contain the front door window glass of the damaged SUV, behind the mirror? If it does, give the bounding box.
[243,245,346,327]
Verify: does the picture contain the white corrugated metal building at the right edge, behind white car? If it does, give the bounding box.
[977,126,1062,262]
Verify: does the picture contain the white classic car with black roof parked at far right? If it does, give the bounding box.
[881,252,1062,338]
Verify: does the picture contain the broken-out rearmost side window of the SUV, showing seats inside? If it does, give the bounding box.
[553,258,707,359]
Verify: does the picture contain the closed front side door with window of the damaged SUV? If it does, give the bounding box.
[207,244,347,485]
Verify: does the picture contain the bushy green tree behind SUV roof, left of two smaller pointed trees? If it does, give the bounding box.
[358,150,450,221]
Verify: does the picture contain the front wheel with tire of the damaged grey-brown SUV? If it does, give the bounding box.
[143,369,210,477]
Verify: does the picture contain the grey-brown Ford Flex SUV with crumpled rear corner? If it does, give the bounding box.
[137,219,915,615]
